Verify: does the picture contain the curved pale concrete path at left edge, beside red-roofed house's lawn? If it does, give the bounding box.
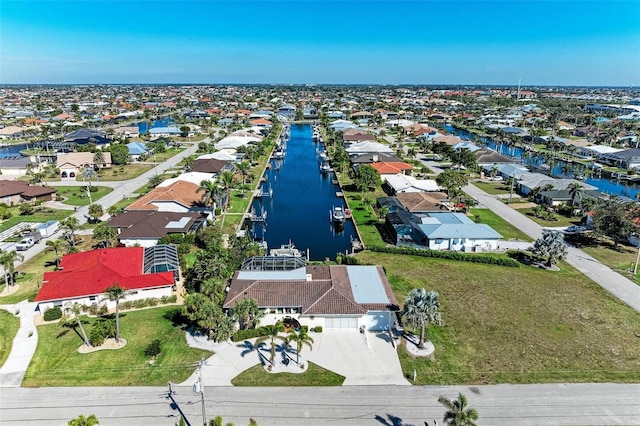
[0,300,38,388]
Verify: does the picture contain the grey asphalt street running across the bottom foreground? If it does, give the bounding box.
[0,383,640,426]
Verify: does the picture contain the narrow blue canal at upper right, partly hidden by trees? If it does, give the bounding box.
[445,125,640,199]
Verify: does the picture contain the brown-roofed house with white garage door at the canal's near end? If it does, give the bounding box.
[223,264,399,330]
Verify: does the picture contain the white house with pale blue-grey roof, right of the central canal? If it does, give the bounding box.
[385,210,502,252]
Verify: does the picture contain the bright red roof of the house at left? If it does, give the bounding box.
[35,247,174,302]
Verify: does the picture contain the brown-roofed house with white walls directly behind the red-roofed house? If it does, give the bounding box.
[107,210,207,247]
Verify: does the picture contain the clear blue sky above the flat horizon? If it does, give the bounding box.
[0,0,640,86]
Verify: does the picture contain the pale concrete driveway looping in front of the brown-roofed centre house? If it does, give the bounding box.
[181,330,410,386]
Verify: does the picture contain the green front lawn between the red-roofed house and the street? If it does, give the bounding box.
[22,306,211,387]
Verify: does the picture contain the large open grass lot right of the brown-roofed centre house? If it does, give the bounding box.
[357,252,640,384]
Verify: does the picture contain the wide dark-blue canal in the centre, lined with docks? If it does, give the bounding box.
[248,124,356,260]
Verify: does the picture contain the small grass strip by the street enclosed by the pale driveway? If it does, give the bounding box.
[231,362,345,386]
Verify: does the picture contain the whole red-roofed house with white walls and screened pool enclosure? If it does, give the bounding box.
[34,246,180,314]
